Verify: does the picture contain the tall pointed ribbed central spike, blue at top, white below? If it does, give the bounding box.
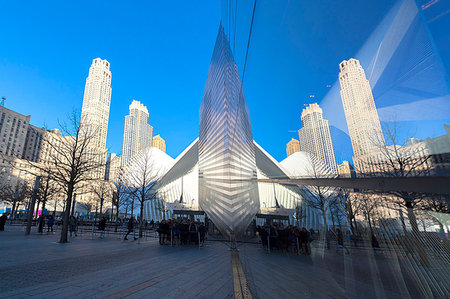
[198,24,259,239]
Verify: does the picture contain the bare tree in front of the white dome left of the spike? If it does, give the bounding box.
[124,148,161,237]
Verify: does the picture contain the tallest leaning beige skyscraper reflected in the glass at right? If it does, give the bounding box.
[339,58,384,157]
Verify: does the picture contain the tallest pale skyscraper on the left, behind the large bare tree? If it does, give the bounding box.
[81,58,111,148]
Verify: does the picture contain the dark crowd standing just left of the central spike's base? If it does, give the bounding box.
[156,218,207,245]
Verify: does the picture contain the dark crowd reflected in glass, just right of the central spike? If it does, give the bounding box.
[256,223,315,255]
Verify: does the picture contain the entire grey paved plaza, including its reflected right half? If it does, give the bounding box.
[0,226,448,298]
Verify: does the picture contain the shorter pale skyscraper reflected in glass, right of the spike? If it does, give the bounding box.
[298,103,338,174]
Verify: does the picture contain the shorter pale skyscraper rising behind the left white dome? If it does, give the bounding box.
[121,100,153,166]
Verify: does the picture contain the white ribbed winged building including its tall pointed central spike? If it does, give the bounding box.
[139,25,324,238]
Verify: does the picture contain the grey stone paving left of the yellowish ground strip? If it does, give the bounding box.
[0,233,236,298]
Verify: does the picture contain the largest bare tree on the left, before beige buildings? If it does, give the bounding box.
[26,112,106,243]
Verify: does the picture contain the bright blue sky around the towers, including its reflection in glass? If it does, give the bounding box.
[0,0,450,162]
